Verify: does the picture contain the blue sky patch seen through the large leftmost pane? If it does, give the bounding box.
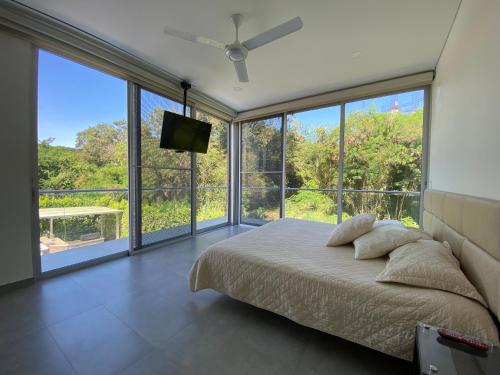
[38,50,127,147]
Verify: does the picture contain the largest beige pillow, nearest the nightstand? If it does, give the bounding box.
[376,240,488,307]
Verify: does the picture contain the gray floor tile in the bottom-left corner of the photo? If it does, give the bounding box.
[0,329,74,375]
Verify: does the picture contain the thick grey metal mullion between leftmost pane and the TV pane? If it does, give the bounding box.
[127,82,142,254]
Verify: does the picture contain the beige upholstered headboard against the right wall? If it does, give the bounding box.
[423,190,500,317]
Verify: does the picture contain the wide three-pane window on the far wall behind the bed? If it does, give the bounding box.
[240,89,425,227]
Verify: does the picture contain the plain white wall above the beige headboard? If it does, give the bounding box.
[429,0,500,200]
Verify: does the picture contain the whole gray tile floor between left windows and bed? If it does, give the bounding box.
[0,226,411,375]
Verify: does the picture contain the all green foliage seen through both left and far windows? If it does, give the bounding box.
[38,108,423,247]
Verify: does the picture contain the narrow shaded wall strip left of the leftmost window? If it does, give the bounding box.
[0,32,36,285]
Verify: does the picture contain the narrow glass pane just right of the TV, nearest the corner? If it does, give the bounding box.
[196,111,229,229]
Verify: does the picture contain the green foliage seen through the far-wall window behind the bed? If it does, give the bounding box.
[242,109,423,226]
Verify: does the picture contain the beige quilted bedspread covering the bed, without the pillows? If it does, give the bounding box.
[189,219,498,360]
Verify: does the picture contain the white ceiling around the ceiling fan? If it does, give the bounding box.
[21,0,459,111]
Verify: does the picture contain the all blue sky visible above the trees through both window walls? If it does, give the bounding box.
[38,50,424,147]
